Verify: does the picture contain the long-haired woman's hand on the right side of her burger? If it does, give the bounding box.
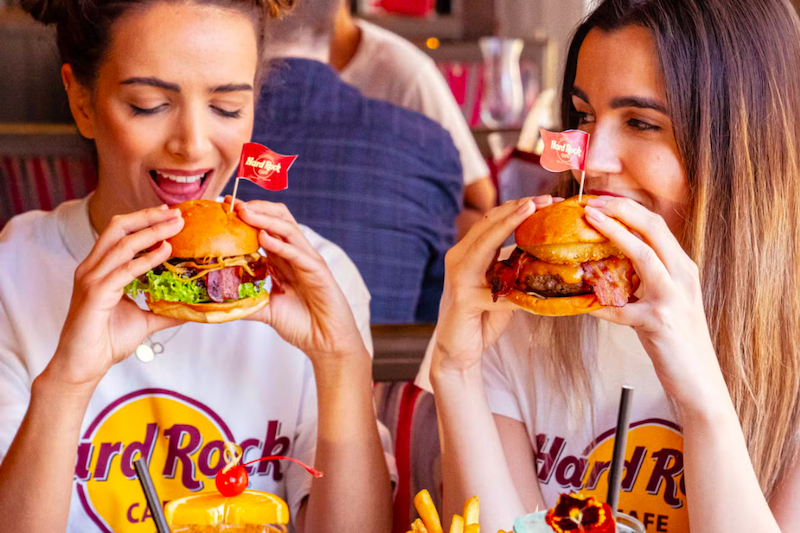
[586,196,729,411]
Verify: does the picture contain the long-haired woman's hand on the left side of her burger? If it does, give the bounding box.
[432,196,553,374]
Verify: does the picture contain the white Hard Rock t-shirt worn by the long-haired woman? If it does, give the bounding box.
[417,311,689,533]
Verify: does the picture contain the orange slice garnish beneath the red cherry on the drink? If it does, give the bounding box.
[164,490,289,533]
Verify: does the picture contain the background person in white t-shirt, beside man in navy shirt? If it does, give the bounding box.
[330,0,497,240]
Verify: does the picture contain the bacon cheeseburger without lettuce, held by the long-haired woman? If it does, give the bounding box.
[487,195,639,316]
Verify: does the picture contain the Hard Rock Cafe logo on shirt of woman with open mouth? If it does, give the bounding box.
[75,389,291,533]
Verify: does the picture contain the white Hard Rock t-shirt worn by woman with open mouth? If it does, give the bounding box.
[0,200,396,533]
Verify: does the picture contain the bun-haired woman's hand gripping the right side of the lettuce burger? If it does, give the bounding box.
[226,198,366,361]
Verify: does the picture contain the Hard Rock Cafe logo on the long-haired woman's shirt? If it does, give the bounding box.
[536,419,689,533]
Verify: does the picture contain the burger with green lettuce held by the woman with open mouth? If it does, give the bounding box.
[125,200,277,322]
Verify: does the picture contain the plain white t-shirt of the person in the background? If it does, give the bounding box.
[340,20,489,185]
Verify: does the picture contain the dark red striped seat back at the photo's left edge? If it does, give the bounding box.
[0,156,97,228]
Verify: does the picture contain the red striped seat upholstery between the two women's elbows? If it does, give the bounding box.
[374,381,442,533]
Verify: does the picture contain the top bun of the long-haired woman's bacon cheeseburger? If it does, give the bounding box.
[514,194,622,265]
